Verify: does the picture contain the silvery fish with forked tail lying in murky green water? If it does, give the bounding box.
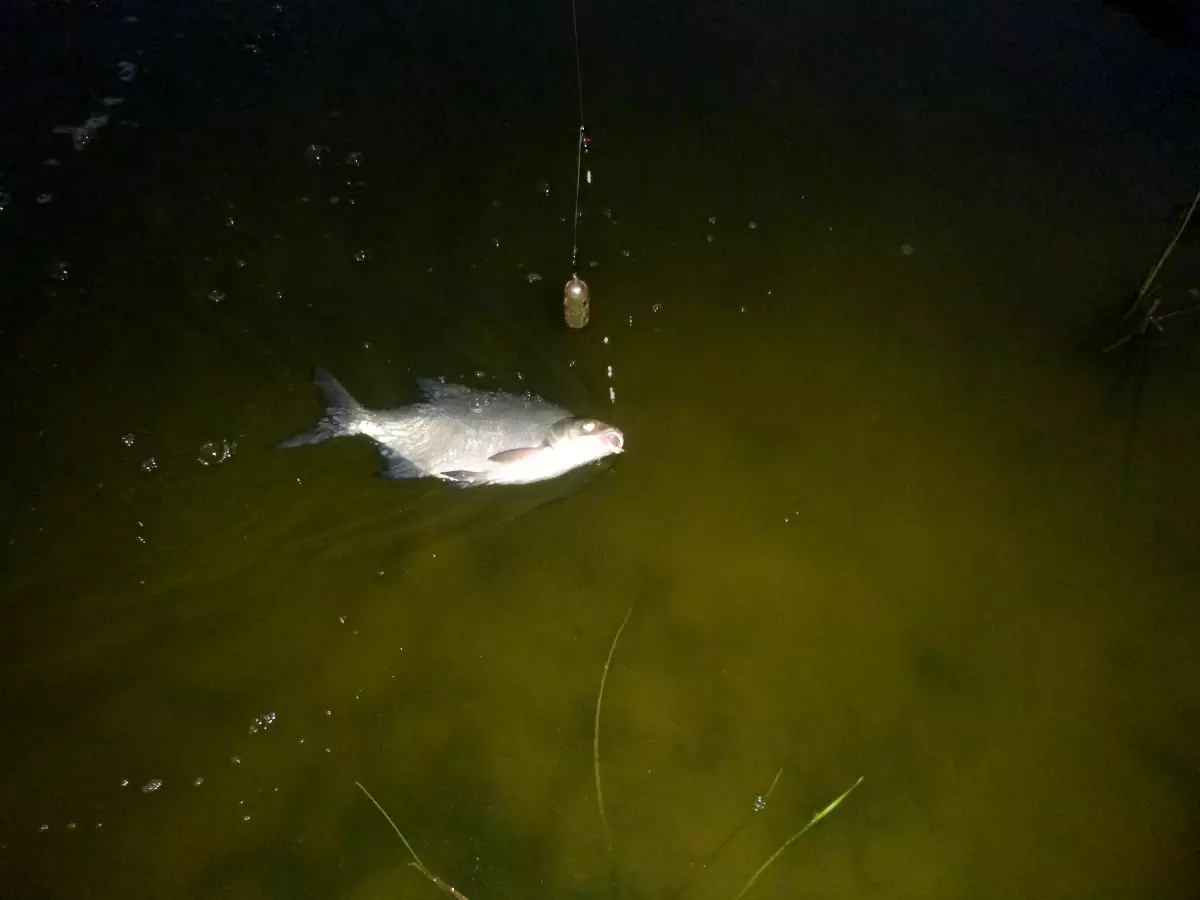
[278,366,625,487]
